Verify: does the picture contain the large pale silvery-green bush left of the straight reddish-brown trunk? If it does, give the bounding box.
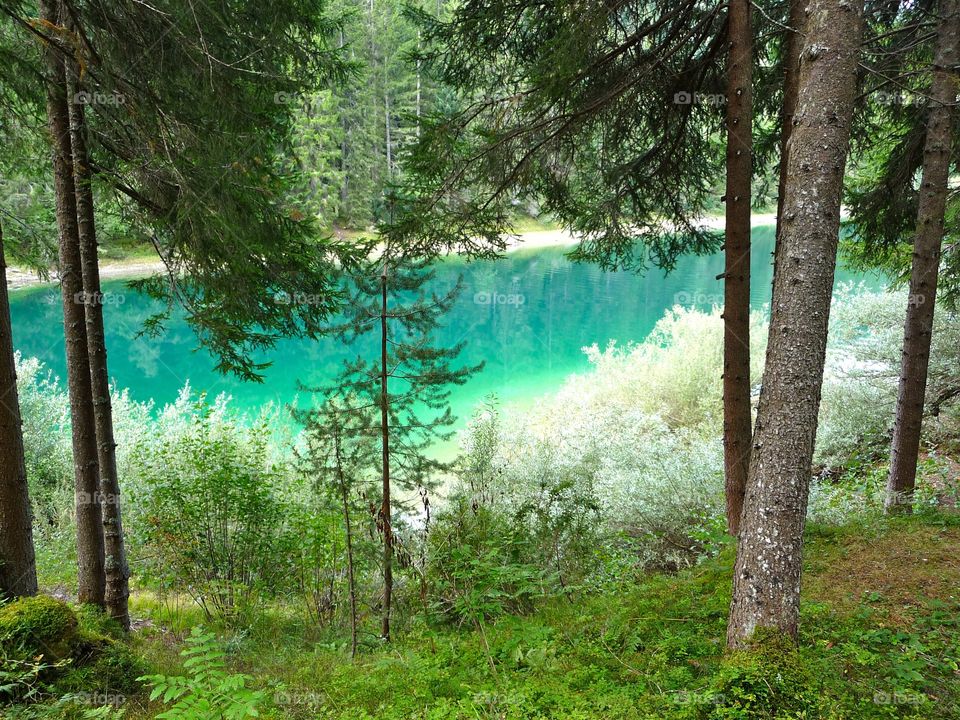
[457,308,732,567]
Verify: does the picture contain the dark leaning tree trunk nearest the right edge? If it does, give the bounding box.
[885,0,960,512]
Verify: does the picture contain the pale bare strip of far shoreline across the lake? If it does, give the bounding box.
[7,213,776,291]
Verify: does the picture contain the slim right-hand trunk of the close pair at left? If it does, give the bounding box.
[67,61,130,630]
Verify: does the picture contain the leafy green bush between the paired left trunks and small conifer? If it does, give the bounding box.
[131,390,287,620]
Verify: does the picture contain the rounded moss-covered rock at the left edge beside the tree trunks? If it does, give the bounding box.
[0,595,79,662]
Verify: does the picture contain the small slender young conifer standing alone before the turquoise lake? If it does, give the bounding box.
[314,235,482,640]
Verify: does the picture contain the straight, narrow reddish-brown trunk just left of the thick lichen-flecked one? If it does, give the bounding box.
[723,0,753,535]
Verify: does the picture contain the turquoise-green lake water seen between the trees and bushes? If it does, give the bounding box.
[11,227,881,422]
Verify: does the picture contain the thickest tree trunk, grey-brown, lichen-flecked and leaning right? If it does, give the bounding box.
[727,0,863,647]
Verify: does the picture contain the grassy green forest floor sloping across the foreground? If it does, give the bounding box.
[112,512,960,720]
